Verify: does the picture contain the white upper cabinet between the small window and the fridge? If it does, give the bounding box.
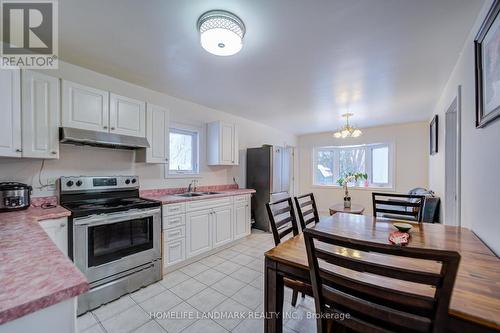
[207,121,239,165]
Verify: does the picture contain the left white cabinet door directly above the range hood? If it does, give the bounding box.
[62,80,109,132]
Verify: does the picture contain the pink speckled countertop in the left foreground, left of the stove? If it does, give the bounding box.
[0,206,89,324]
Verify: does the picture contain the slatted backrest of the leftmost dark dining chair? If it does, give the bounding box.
[266,197,299,245]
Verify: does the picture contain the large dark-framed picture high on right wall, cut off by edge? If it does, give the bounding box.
[474,0,500,128]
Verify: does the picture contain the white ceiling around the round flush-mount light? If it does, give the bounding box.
[59,0,484,134]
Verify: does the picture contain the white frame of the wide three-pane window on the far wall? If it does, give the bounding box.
[311,142,396,190]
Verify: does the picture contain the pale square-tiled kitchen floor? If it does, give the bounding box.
[77,232,316,333]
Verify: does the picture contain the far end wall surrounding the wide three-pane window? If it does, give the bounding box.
[299,122,429,214]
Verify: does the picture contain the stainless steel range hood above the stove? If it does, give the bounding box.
[59,127,149,149]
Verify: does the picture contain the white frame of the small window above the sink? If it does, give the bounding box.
[165,123,201,178]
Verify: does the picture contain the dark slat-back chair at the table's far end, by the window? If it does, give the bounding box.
[372,192,425,222]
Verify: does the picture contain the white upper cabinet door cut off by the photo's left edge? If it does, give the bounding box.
[0,69,22,157]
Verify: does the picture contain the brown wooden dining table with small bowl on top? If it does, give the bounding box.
[264,213,500,333]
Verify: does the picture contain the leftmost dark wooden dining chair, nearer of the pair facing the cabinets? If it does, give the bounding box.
[266,197,312,306]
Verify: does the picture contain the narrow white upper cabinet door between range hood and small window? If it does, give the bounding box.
[146,103,170,163]
